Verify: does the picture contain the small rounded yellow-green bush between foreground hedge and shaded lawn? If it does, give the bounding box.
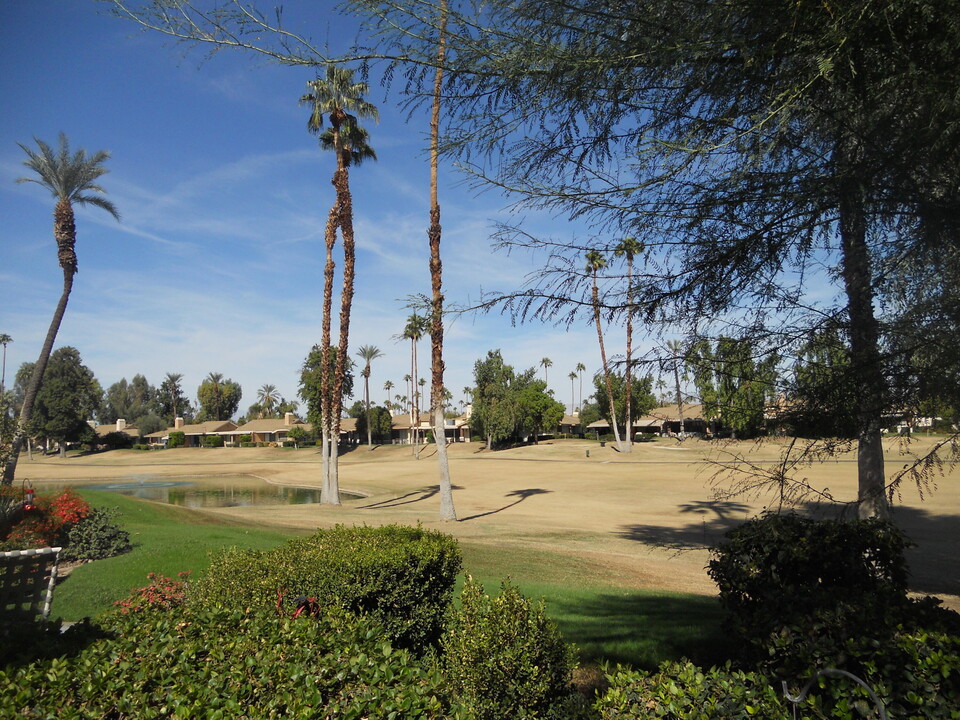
[442,578,580,720]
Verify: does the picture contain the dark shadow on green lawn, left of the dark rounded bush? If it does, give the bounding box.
[550,593,730,670]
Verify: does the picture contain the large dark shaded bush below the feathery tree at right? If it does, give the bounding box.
[708,514,909,677]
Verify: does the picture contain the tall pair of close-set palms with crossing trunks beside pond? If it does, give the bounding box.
[300,65,379,505]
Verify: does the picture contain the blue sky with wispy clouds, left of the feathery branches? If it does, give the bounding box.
[0,0,622,412]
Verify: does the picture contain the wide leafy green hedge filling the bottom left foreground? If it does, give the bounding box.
[0,606,452,720]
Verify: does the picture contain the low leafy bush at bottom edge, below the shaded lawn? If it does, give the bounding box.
[594,662,793,720]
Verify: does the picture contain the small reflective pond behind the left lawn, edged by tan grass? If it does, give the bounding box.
[69,475,360,508]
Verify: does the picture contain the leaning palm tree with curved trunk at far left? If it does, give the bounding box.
[3,133,120,485]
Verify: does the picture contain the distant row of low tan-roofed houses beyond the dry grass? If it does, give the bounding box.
[94,405,707,447]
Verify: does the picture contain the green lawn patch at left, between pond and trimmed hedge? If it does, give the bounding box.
[51,490,292,621]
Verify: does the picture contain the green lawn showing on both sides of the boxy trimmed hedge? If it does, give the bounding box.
[52,490,722,669]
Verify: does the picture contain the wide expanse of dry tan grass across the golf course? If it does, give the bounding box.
[18,440,960,608]
